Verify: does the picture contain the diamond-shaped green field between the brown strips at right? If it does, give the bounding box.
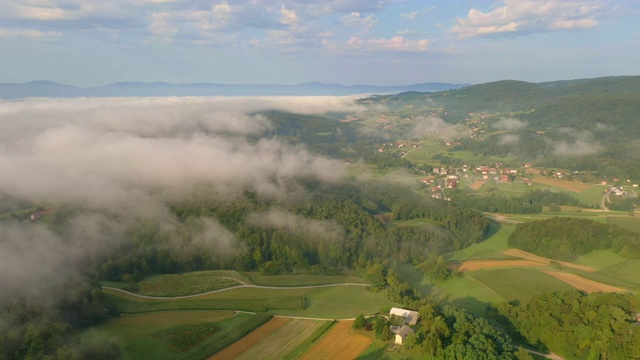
[467,268,573,301]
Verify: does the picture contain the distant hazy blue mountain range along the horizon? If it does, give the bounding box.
[0,81,469,99]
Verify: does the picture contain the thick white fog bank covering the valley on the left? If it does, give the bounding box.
[0,97,358,295]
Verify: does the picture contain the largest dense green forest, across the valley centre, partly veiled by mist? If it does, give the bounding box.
[97,181,489,281]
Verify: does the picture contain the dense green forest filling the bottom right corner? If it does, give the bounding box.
[496,291,640,359]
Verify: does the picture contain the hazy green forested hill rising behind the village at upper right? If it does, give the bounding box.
[361,76,640,178]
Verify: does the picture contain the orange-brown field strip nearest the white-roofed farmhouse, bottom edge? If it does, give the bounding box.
[301,320,372,360]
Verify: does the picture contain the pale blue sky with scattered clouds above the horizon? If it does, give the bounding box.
[0,0,640,86]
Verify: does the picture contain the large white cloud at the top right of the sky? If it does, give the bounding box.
[450,0,601,37]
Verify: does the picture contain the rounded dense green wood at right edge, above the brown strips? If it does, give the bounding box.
[509,217,640,261]
